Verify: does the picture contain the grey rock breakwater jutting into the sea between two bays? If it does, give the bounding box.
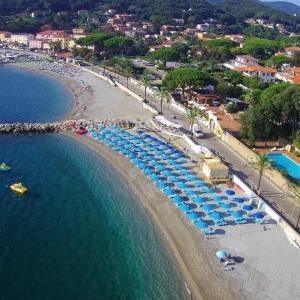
[0,123,65,134]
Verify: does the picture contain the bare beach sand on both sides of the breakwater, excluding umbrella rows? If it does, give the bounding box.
[7,59,300,300]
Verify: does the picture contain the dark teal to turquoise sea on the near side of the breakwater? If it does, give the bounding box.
[0,70,186,300]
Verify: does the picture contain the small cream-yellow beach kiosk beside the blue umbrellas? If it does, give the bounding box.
[202,157,229,182]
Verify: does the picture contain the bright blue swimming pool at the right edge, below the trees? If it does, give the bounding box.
[267,153,300,180]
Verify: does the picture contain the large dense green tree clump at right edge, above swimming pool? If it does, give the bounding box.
[241,83,300,144]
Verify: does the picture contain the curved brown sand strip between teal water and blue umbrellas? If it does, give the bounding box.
[61,132,247,300]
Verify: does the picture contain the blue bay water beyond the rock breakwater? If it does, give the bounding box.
[0,67,74,123]
